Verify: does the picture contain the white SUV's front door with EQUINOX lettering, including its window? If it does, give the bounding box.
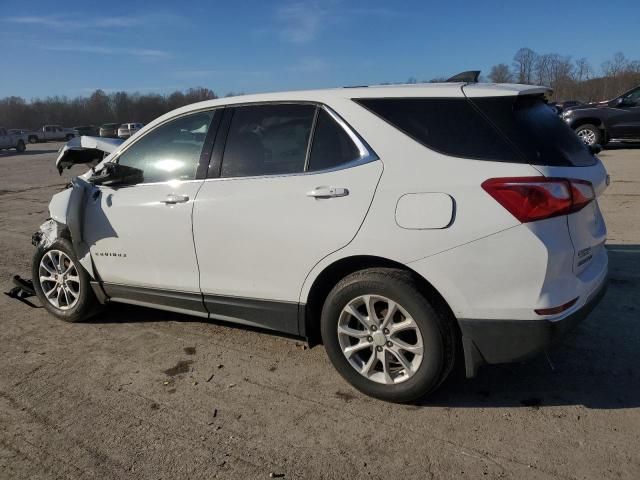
[84,111,219,312]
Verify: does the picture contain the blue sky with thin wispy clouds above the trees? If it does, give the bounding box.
[0,0,640,99]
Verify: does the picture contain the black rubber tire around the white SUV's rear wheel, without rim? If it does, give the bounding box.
[321,268,455,403]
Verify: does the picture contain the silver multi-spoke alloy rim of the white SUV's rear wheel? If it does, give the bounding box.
[338,295,424,385]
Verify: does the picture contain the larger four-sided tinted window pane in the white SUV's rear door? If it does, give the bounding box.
[221,104,316,177]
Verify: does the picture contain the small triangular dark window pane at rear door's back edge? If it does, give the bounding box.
[308,109,360,171]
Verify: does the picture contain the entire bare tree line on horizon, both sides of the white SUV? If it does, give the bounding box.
[0,48,640,129]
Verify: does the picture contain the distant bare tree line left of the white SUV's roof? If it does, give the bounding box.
[0,87,222,129]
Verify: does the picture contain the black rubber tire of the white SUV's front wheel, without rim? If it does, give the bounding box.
[31,238,99,322]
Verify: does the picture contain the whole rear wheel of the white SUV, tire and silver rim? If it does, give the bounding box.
[321,268,455,402]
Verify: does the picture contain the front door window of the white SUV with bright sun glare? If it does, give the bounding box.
[118,111,214,183]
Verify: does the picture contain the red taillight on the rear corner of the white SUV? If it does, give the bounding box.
[482,177,595,223]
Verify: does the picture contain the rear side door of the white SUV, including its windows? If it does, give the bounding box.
[193,103,382,334]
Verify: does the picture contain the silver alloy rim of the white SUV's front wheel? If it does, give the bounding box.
[38,250,80,310]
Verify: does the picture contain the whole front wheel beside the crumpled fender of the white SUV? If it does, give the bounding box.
[31,238,98,322]
